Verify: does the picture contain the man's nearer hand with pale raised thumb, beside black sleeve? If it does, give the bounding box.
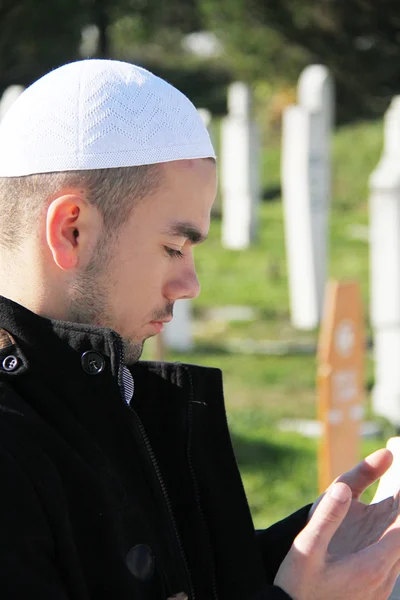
[274,482,400,600]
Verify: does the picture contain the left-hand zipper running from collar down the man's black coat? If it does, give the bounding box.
[118,340,196,600]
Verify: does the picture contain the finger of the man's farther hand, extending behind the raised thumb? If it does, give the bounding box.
[336,448,393,499]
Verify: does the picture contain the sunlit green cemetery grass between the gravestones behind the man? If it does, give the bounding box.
[145,117,394,527]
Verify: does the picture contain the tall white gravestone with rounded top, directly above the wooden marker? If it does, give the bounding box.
[282,65,334,330]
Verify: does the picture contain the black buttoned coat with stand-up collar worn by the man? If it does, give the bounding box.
[0,299,308,600]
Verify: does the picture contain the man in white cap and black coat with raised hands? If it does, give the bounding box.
[0,60,400,600]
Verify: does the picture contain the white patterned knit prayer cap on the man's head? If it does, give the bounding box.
[0,59,215,177]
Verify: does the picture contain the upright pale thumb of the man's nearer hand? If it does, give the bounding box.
[296,483,351,558]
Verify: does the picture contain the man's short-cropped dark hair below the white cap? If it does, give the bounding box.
[0,165,162,251]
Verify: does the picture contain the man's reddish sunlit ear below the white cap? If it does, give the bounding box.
[46,194,88,270]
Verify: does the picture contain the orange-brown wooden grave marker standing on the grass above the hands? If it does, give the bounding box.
[317,281,365,492]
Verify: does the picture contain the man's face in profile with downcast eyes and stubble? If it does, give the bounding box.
[69,160,217,364]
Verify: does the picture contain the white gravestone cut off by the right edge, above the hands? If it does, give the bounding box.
[370,96,400,427]
